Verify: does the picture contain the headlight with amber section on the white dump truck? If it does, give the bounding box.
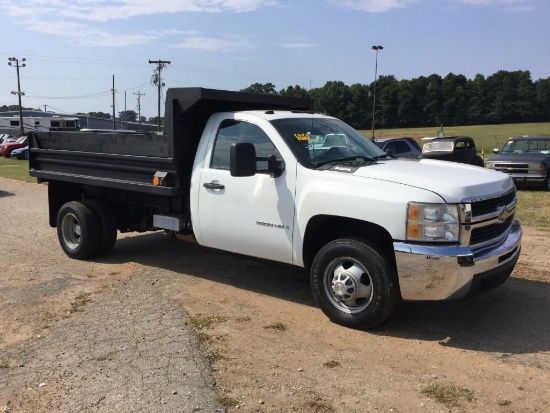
[407,202,460,242]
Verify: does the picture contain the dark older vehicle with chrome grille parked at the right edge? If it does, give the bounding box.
[485,136,550,191]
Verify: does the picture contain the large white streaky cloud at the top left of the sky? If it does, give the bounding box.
[0,0,279,47]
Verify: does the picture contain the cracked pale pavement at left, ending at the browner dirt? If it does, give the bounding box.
[0,178,223,413]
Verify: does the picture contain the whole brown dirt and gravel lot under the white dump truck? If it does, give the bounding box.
[0,178,550,413]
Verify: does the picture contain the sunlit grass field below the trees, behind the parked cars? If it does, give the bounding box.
[361,122,550,158]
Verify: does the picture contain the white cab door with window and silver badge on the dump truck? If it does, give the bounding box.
[197,119,296,263]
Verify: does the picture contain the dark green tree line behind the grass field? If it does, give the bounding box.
[242,70,550,129]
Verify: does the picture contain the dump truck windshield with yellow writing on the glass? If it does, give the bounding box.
[271,117,386,167]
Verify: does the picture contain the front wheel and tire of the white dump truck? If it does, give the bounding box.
[311,238,399,329]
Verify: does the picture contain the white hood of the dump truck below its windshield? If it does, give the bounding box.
[354,159,514,202]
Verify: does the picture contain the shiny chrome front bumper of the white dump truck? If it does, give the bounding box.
[393,221,522,301]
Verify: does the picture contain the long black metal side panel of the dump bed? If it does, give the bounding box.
[29,132,182,196]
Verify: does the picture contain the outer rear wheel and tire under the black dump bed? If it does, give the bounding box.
[57,201,100,260]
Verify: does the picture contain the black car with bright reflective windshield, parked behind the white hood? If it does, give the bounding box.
[422,136,483,166]
